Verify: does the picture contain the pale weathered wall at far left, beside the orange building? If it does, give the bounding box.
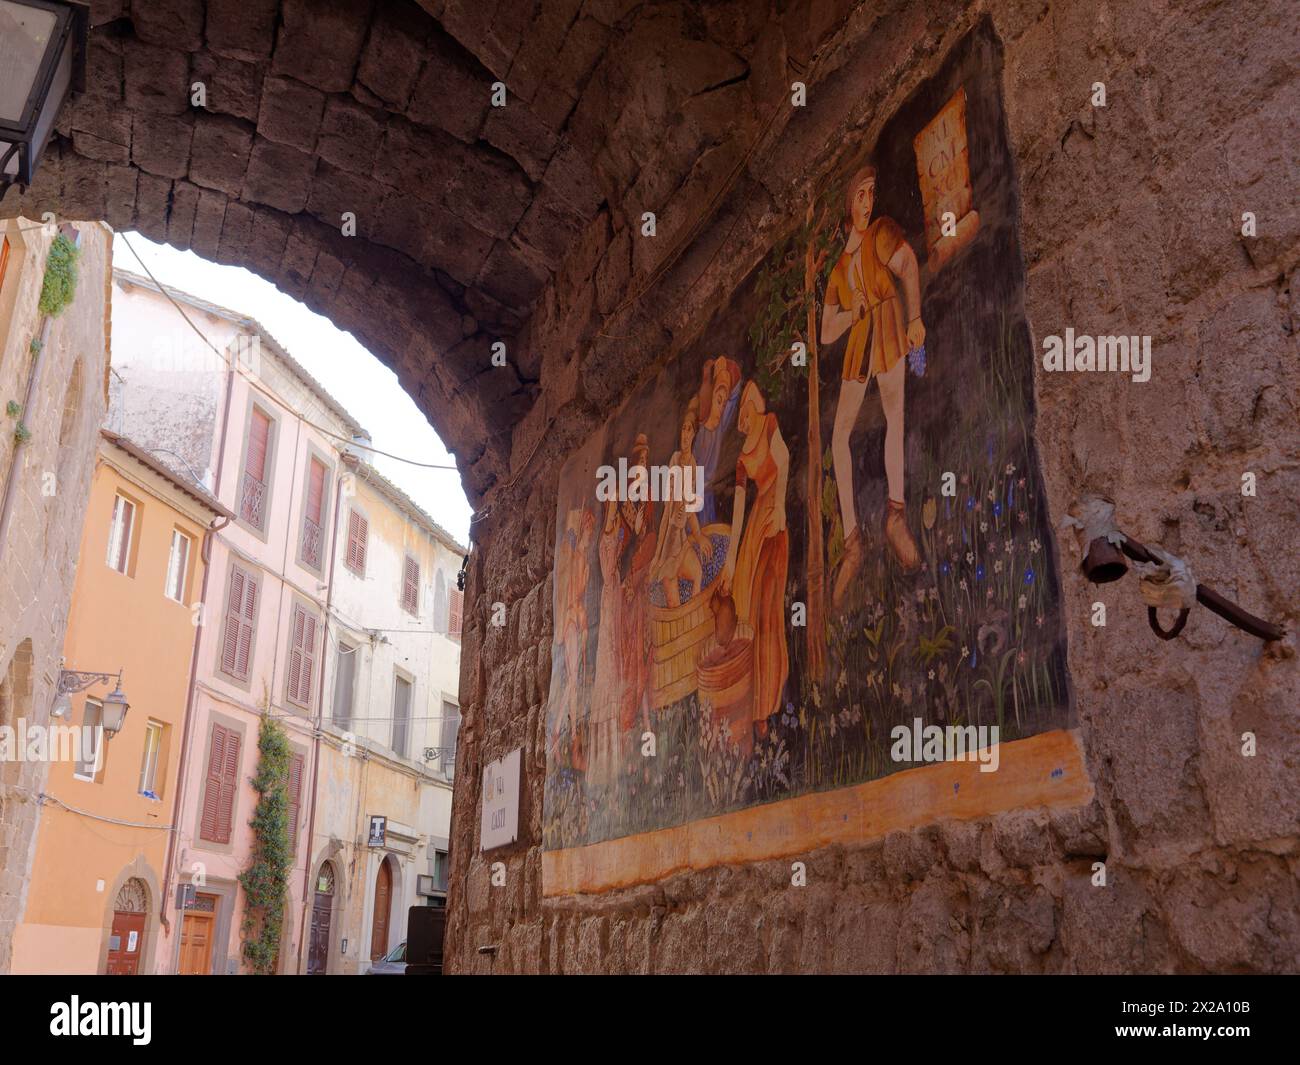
[0,218,112,973]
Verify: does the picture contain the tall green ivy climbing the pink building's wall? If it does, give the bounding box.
[239,715,294,974]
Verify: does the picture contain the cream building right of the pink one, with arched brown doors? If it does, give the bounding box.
[302,455,465,973]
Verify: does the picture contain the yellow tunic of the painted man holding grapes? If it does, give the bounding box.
[828,217,907,381]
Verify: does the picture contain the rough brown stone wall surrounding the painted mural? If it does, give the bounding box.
[447,0,1300,973]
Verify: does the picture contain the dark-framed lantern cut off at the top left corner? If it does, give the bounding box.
[0,0,90,198]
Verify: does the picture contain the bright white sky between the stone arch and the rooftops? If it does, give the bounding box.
[113,233,471,544]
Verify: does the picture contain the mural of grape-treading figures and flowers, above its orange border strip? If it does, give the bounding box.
[543,30,1073,868]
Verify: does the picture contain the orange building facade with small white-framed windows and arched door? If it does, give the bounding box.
[12,430,233,975]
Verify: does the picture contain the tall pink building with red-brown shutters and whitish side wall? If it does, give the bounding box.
[109,273,363,974]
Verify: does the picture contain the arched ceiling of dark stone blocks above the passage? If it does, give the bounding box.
[0,0,832,499]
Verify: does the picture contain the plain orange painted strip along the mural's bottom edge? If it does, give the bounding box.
[542,730,1093,897]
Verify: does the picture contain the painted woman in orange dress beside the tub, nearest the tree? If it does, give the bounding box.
[723,381,790,739]
